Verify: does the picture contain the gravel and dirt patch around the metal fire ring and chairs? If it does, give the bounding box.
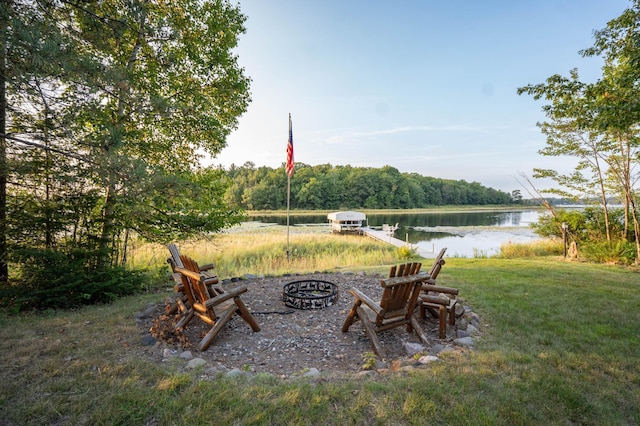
[143,273,464,376]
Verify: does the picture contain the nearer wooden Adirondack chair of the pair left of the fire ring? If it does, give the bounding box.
[176,267,260,351]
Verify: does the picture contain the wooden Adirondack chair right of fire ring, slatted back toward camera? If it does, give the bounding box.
[342,263,429,359]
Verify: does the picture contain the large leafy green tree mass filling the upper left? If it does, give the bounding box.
[0,0,250,276]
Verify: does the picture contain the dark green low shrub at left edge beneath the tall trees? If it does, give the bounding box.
[0,248,145,311]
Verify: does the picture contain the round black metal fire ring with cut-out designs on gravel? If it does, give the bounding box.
[282,280,338,309]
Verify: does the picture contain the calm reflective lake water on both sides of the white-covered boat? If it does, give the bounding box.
[250,209,540,257]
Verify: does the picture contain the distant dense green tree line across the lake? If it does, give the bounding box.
[225,162,518,210]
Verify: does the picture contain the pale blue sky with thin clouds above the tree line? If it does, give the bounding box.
[212,0,631,193]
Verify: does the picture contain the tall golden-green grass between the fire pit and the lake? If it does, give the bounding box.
[124,224,408,278]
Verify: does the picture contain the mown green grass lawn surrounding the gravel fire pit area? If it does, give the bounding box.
[0,258,640,425]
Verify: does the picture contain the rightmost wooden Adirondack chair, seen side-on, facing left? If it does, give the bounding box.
[420,247,458,339]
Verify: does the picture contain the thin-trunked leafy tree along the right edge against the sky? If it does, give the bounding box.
[518,0,640,263]
